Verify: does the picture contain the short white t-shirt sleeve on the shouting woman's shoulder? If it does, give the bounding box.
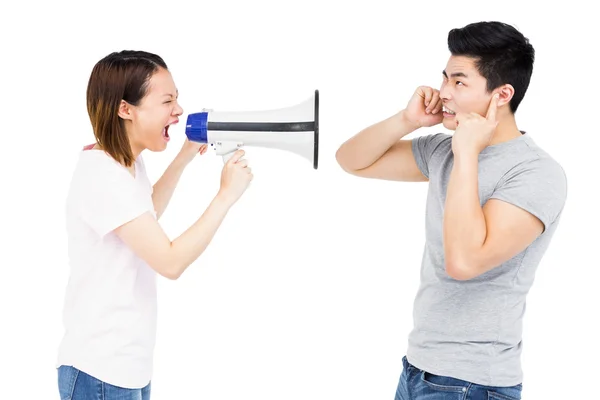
[78,162,152,237]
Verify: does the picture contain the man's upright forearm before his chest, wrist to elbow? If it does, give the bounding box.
[444,153,487,279]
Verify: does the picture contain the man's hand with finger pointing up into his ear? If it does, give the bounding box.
[452,94,499,156]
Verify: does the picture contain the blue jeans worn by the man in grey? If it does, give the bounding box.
[396,357,523,400]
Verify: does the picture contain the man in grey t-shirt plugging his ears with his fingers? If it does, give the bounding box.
[336,22,567,400]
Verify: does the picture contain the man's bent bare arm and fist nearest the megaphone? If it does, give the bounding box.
[336,87,442,182]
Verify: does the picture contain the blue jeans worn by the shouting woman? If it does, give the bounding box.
[58,365,150,400]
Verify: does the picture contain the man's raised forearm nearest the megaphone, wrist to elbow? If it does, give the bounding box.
[336,111,418,170]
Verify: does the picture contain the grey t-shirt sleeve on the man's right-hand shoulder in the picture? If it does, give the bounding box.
[490,158,567,231]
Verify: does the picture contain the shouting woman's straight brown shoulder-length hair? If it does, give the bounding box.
[87,50,168,167]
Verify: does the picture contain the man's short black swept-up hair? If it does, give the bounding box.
[448,21,535,114]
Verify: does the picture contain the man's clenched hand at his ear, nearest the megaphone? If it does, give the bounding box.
[402,86,444,129]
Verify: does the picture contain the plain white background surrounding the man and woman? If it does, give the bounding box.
[0,0,600,400]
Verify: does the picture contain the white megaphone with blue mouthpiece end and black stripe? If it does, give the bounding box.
[185,90,319,169]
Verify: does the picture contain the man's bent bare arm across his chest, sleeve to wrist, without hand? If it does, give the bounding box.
[444,153,544,280]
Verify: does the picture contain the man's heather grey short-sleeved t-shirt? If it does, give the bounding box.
[407,133,567,386]
